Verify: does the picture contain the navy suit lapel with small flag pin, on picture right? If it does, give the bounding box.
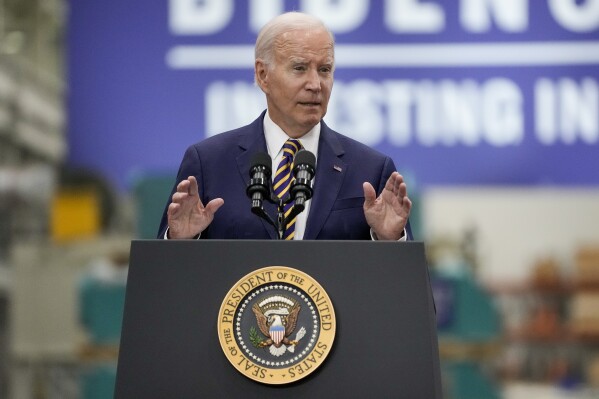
[304,122,347,240]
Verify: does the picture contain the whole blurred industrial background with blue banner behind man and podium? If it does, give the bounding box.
[0,0,599,399]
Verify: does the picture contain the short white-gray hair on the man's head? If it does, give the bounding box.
[255,11,335,68]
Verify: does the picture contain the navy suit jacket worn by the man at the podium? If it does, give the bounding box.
[158,112,412,240]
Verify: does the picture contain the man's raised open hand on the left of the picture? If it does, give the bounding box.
[167,176,225,239]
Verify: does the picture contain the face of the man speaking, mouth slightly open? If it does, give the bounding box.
[256,29,334,138]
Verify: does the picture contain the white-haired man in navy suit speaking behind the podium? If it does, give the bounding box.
[158,12,412,240]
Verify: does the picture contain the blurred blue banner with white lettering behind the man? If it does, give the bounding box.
[67,0,599,188]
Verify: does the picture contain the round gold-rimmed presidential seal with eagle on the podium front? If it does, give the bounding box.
[218,266,336,384]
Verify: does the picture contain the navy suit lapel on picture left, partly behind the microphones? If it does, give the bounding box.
[236,111,277,240]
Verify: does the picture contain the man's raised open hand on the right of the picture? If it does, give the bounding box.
[363,172,412,240]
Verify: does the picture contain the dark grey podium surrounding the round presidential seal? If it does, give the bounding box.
[115,240,441,399]
